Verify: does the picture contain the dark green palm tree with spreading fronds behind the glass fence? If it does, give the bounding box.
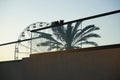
[37,22,100,50]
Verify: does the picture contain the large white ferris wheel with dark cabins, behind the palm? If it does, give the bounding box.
[14,22,50,60]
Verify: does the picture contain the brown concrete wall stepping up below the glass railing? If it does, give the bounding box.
[0,45,120,80]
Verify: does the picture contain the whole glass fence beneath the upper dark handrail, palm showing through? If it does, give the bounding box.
[32,14,120,53]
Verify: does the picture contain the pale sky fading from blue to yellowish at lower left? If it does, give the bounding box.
[0,0,120,61]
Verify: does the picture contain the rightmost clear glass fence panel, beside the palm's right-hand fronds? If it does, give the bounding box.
[82,14,120,47]
